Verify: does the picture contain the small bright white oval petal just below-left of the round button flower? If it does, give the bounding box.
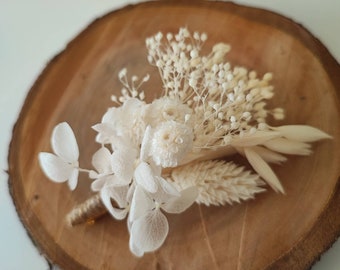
[134,162,158,193]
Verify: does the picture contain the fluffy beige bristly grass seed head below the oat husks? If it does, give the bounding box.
[167,160,265,206]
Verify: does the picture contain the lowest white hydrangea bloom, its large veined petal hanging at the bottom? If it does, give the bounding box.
[129,181,197,257]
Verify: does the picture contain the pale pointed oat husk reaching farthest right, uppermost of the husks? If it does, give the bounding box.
[273,125,332,142]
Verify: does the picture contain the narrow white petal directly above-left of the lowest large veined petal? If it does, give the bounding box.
[129,185,155,222]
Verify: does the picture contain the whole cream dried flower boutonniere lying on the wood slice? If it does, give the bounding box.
[39,28,331,256]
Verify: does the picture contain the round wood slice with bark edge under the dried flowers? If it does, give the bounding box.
[9,1,340,270]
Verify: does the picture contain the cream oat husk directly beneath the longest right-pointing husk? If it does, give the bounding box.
[263,138,312,156]
